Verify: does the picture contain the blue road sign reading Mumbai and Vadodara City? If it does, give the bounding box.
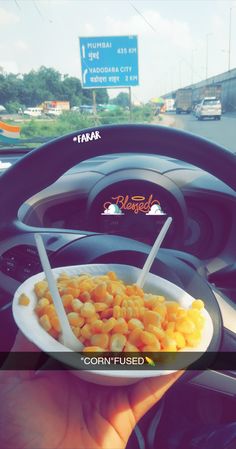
[79,36,139,88]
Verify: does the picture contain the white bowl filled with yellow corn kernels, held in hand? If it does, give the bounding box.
[13,264,213,385]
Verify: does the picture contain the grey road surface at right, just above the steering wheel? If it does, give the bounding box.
[168,113,236,153]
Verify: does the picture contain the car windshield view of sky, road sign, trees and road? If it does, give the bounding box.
[0,0,236,152]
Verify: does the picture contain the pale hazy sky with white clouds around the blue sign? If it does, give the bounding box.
[0,0,236,102]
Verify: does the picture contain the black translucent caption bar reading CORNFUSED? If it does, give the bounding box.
[0,352,236,371]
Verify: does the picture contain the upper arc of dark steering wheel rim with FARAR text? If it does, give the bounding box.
[0,125,236,232]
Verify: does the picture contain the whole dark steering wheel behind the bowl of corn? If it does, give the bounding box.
[0,125,236,364]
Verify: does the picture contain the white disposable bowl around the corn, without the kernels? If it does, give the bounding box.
[12,264,213,386]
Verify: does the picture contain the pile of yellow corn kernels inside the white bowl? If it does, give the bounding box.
[30,271,205,352]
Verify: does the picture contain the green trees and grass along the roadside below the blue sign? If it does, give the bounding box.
[0,67,158,141]
